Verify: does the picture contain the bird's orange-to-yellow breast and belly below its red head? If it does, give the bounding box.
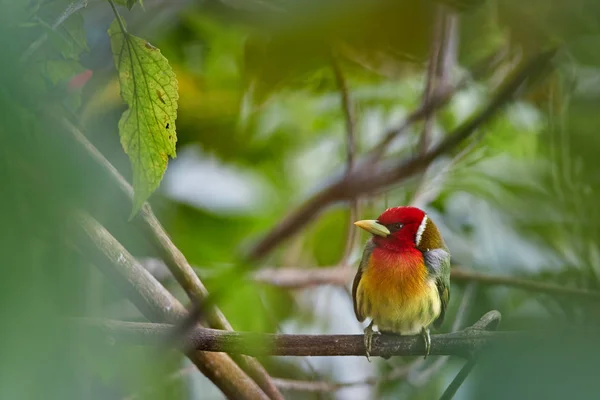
[356,250,441,335]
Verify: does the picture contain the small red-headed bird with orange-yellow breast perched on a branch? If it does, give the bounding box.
[352,207,450,359]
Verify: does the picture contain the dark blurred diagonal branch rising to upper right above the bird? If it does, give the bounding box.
[248,50,555,260]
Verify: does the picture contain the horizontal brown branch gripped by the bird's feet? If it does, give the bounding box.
[77,311,508,358]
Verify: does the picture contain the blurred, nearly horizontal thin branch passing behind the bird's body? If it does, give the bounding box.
[253,267,600,301]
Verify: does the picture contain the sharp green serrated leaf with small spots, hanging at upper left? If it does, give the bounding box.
[108,20,179,218]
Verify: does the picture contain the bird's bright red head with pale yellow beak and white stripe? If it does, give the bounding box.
[355,207,439,251]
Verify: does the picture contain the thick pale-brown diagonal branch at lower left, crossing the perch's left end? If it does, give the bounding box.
[73,212,268,399]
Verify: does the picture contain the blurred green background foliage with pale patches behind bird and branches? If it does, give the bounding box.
[5,0,600,399]
